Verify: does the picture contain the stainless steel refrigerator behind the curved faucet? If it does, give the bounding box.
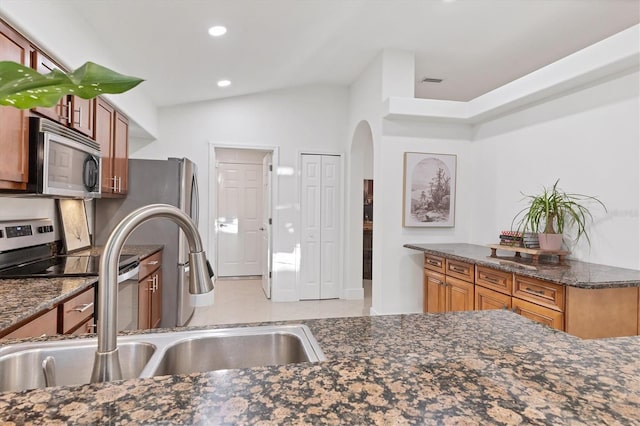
[94,158,199,327]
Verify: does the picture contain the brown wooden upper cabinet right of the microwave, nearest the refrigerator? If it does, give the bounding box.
[93,98,129,197]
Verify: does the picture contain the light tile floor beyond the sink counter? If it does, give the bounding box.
[189,279,371,325]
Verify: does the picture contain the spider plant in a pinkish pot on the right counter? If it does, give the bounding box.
[512,179,607,251]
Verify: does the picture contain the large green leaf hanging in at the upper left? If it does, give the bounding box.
[0,61,144,109]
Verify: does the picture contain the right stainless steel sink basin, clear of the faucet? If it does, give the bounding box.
[150,328,319,376]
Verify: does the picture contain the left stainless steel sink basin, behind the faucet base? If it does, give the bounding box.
[0,339,156,392]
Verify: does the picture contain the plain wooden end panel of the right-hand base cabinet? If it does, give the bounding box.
[565,287,639,339]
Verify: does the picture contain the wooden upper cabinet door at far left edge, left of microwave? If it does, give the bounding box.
[0,21,32,190]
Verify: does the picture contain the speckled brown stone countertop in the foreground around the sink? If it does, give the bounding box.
[0,310,640,425]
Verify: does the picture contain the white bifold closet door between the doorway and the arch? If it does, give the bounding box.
[300,154,342,300]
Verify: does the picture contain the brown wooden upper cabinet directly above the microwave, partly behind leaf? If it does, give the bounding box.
[31,50,94,137]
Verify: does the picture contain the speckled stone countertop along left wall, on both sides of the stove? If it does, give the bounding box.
[0,245,163,330]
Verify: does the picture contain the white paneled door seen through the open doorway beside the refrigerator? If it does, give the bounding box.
[218,163,263,277]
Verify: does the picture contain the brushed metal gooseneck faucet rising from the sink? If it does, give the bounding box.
[91,204,213,383]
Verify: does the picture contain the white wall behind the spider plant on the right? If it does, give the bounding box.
[469,71,640,269]
